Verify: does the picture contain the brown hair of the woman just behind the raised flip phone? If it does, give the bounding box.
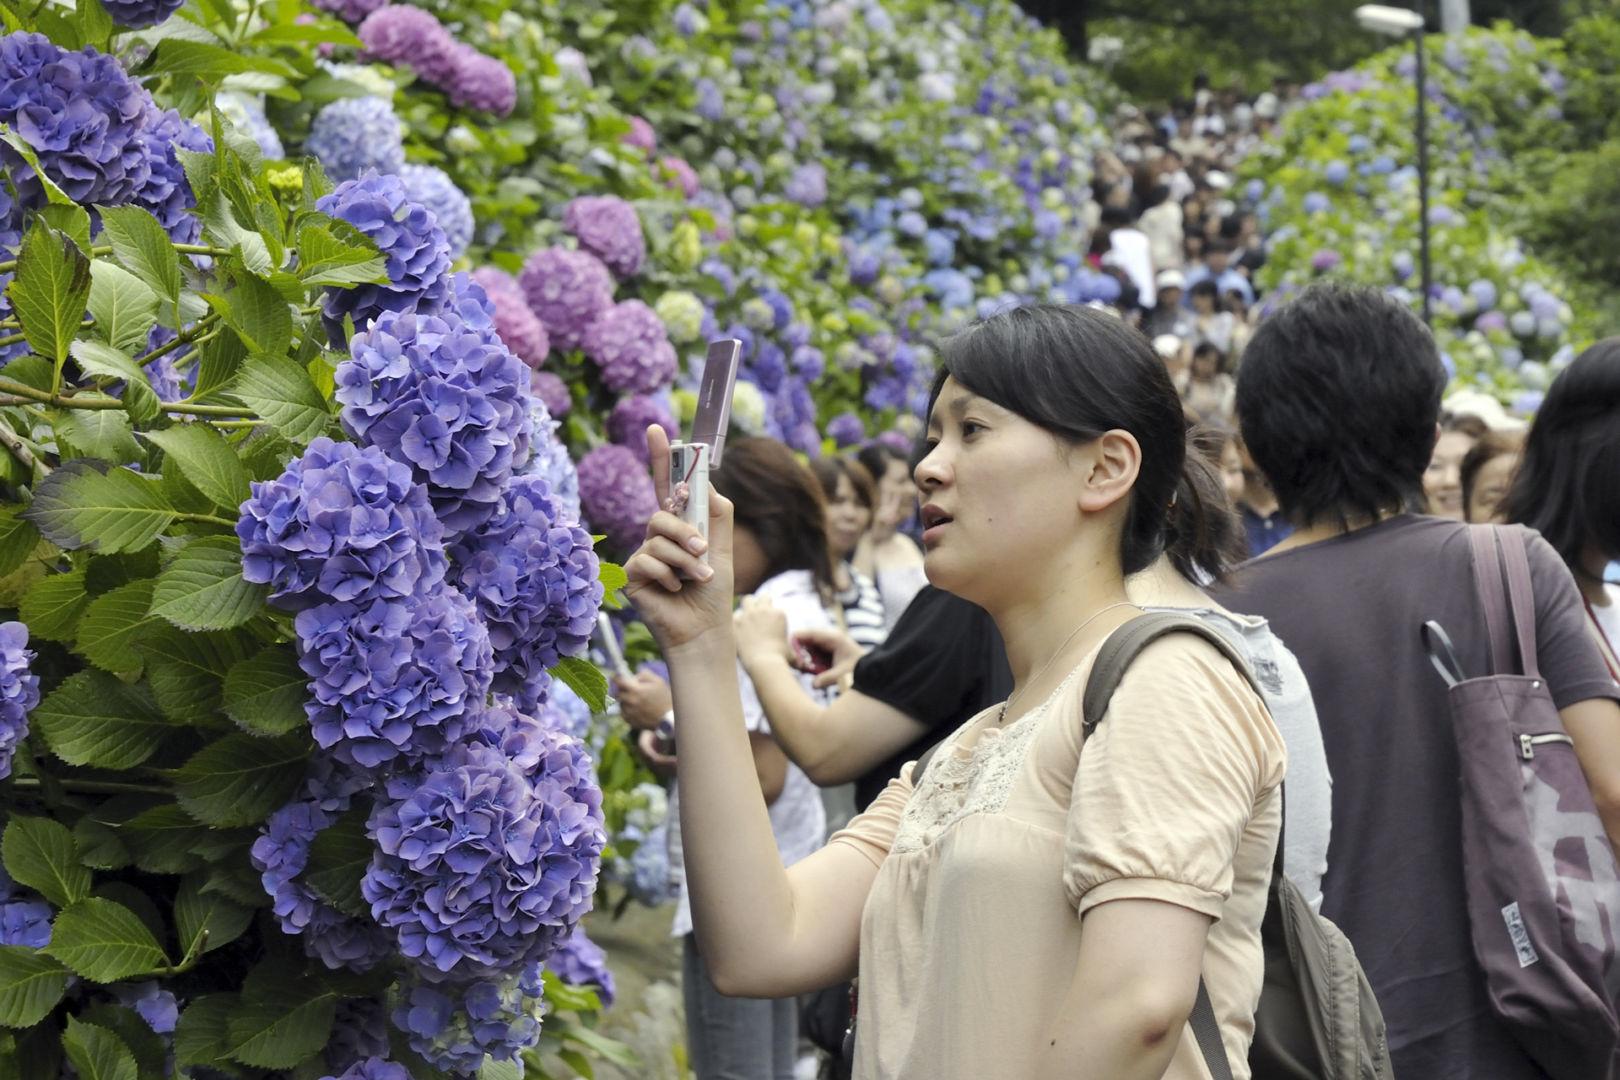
[710,437,834,596]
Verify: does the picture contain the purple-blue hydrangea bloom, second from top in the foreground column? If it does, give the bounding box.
[334,274,530,539]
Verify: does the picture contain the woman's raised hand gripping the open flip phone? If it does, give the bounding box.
[624,424,732,653]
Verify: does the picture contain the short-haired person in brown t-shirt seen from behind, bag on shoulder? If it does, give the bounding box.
[1210,287,1620,1080]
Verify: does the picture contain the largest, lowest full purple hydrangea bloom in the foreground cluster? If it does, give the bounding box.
[360,732,606,978]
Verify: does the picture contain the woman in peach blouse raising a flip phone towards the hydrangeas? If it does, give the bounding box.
[627,306,1286,1080]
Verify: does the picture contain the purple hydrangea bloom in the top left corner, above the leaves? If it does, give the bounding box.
[0,32,152,207]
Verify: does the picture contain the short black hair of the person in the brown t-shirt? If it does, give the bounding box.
[1238,285,1445,525]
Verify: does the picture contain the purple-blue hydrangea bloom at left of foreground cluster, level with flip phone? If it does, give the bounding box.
[237,436,446,610]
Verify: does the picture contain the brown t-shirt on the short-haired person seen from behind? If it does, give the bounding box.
[1210,515,1620,1080]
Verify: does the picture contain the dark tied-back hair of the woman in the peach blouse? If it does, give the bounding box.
[928,304,1223,581]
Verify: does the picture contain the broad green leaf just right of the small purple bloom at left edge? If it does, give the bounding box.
[31,670,173,769]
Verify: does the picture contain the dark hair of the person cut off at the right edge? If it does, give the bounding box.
[1502,337,1620,576]
